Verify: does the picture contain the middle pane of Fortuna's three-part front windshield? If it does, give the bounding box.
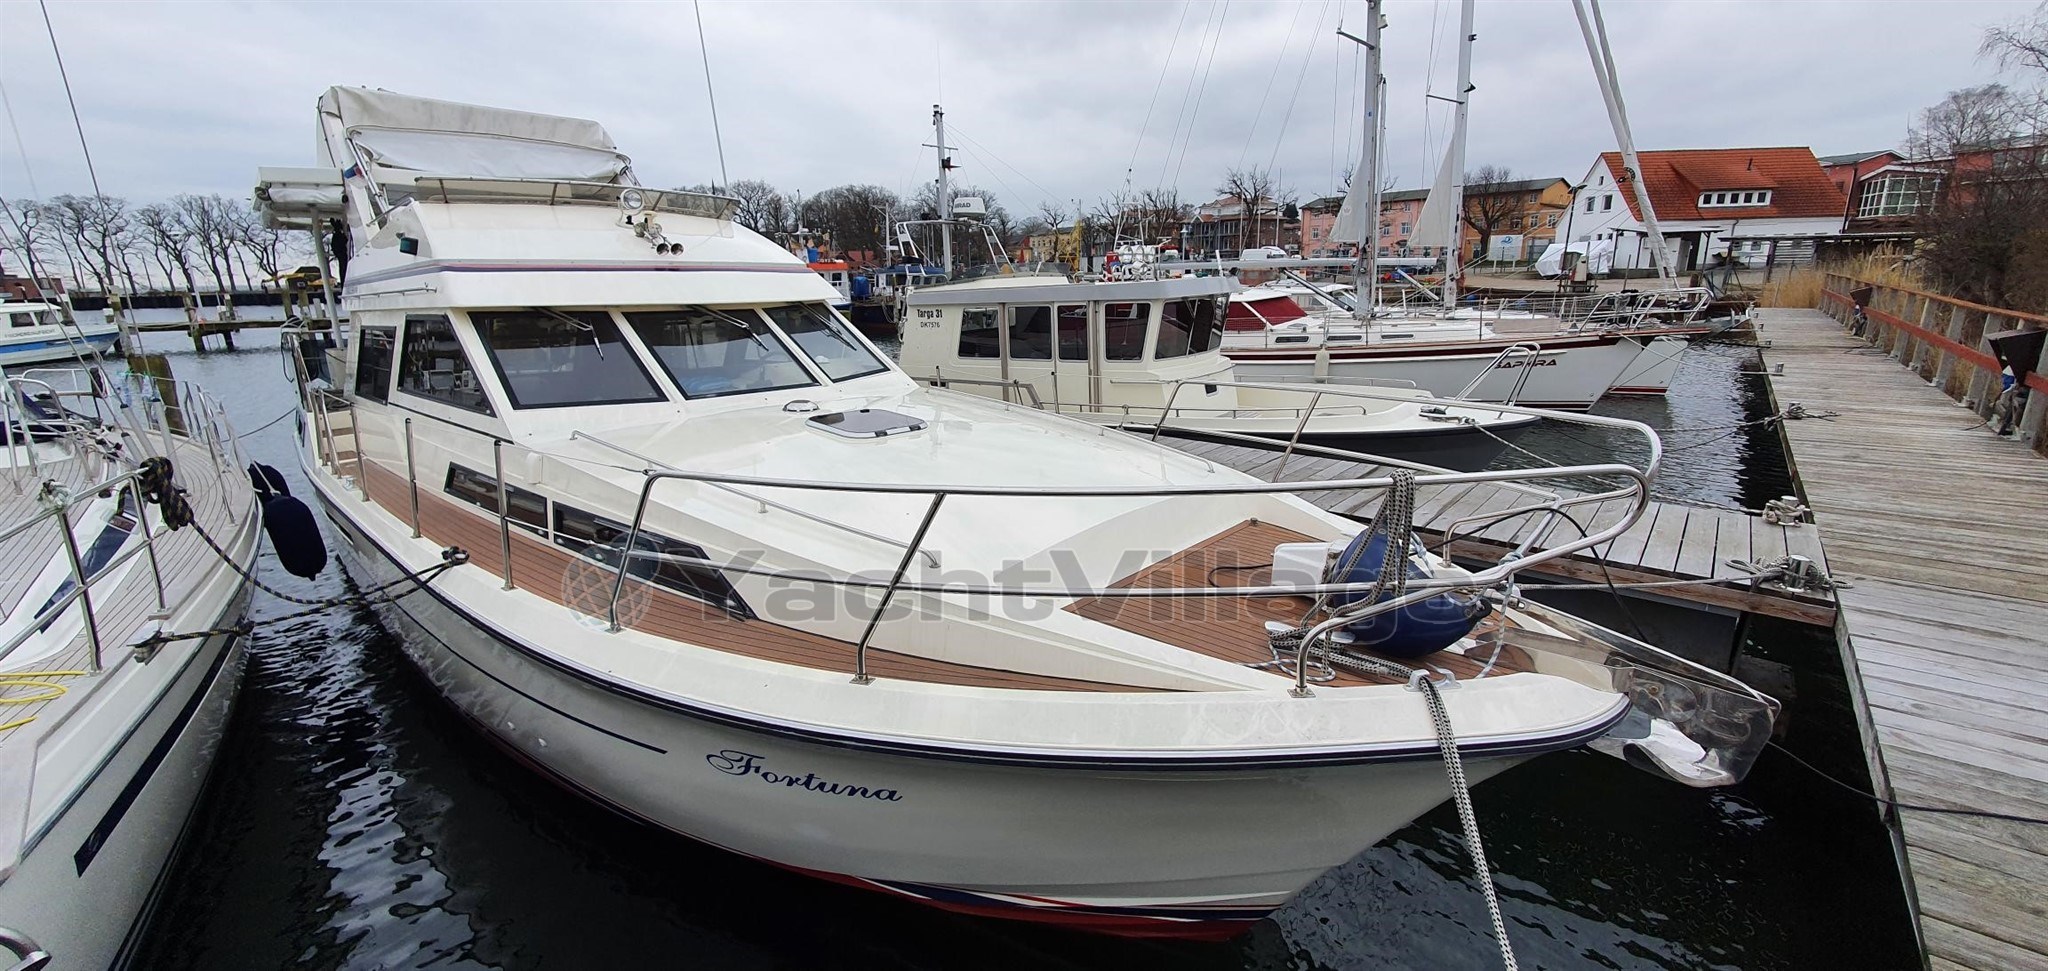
[627,307,817,397]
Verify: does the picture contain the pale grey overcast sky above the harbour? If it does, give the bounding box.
[0,0,2034,215]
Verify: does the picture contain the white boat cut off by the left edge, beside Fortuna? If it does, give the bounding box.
[0,361,262,969]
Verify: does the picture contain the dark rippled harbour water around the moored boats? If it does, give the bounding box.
[79,315,1919,969]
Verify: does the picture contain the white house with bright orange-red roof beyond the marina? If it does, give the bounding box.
[1561,147,1847,272]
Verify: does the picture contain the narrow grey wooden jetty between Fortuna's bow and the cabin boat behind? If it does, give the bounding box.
[1159,436,1835,625]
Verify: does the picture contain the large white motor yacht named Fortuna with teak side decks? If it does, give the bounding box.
[256,88,1776,936]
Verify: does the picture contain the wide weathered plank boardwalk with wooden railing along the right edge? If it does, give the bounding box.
[1759,309,2048,971]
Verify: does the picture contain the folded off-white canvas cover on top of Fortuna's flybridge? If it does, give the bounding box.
[319,88,633,182]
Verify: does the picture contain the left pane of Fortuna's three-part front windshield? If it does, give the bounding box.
[469,309,664,408]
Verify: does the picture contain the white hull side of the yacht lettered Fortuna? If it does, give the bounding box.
[307,481,1559,936]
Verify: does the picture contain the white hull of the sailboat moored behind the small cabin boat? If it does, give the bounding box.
[1225,340,1640,412]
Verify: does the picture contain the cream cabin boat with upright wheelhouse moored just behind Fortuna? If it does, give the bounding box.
[899,275,1538,471]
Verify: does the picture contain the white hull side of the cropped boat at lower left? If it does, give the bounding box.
[0,618,248,971]
